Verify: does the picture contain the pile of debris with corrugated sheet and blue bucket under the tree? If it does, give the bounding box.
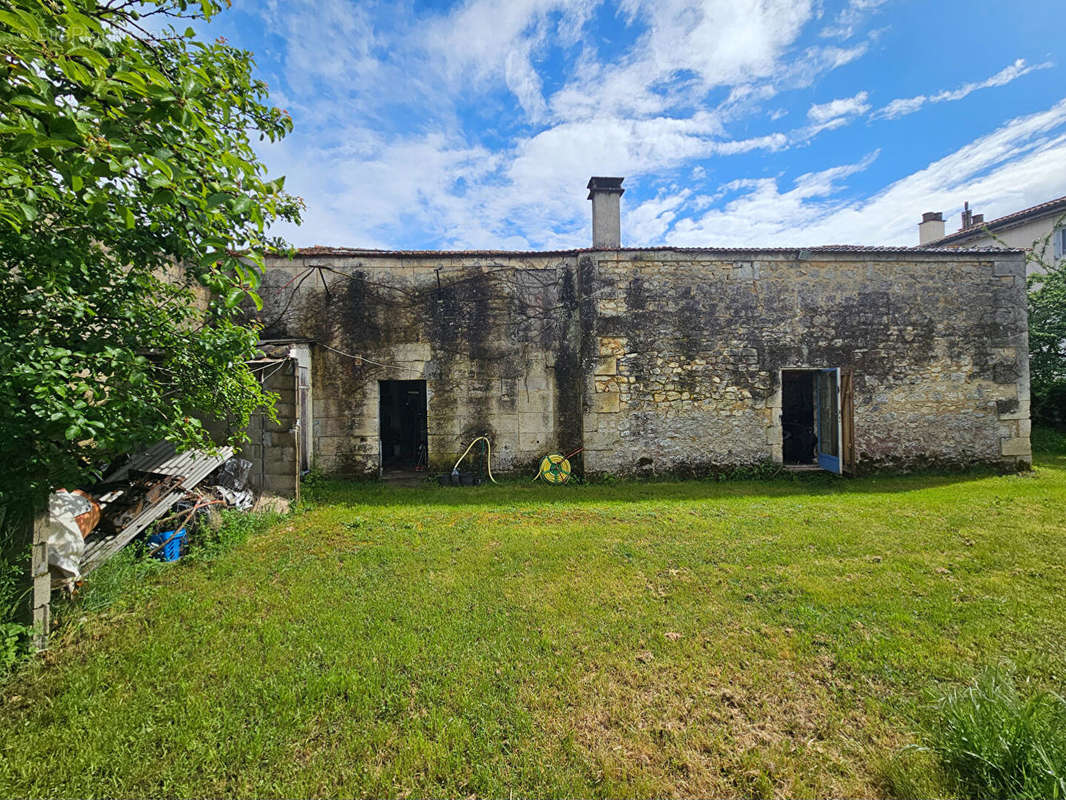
[47,443,256,589]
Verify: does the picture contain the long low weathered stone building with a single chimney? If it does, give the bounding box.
[244,178,1030,492]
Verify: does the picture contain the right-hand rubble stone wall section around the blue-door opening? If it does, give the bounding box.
[584,251,1029,473]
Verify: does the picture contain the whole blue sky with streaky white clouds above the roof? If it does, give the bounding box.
[189,0,1066,250]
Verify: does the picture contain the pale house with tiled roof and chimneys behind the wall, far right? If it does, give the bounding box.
[918,197,1066,272]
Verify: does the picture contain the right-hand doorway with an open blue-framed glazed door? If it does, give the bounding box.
[781,367,852,474]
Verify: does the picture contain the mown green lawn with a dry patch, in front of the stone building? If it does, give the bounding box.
[0,441,1066,797]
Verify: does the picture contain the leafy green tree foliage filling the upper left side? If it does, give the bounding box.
[0,0,302,496]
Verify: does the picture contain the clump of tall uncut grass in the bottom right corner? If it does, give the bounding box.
[912,670,1066,799]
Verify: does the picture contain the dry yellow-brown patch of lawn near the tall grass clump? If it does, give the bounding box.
[533,650,899,797]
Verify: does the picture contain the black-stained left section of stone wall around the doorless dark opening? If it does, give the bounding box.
[261,254,583,475]
